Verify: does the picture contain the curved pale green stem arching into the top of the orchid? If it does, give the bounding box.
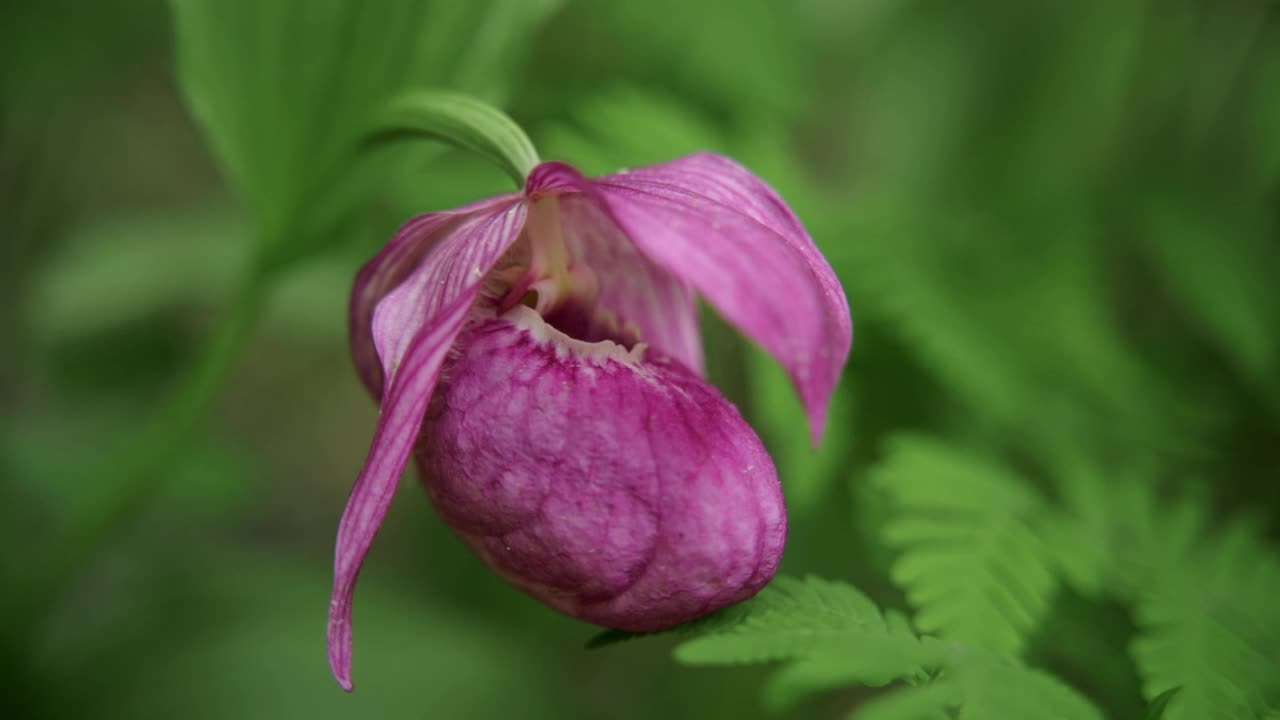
[372,90,539,187]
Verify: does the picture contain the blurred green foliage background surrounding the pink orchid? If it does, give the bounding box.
[0,0,1280,719]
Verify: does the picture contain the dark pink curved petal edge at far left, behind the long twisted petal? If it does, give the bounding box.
[348,195,515,400]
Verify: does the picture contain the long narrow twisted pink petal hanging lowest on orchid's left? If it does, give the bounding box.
[329,199,526,689]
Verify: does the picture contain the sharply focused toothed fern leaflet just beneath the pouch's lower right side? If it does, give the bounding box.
[675,577,922,667]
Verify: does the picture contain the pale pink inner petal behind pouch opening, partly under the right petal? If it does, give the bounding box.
[559,195,705,375]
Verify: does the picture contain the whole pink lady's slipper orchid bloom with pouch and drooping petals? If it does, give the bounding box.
[329,154,852,689]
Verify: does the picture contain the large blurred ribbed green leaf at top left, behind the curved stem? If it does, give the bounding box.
[170,0,554,266]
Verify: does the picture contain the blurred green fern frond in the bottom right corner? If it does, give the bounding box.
[1132,521,1280,720]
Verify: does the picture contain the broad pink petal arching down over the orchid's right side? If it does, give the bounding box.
[526,154,852,443]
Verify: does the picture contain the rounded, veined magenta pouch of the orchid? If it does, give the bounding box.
[416,306,786,630]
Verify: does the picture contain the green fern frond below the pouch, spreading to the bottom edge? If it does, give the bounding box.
[650,568,1101,720]
